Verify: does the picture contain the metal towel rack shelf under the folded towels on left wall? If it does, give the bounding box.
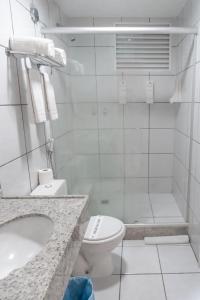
[6,48,64,68]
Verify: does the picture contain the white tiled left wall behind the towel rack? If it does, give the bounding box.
[0,0,72,195]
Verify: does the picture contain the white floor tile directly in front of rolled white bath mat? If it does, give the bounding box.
[158,245,200,274]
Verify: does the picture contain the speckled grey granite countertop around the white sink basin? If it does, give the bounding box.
[0,196,88,300]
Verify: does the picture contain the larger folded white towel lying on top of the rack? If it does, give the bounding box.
[10,36,55,57]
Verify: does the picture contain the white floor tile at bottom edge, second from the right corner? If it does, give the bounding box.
[120,275,165,300]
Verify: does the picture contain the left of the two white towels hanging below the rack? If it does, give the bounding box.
[28,69,46,123]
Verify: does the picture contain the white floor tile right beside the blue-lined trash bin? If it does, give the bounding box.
[92,275,120,300]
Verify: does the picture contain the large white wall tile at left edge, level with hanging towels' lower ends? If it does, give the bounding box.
[0,106,26,165]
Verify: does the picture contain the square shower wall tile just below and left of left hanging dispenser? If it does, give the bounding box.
[98,103,123,128]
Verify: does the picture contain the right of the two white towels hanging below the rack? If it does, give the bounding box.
[42,72,58,120]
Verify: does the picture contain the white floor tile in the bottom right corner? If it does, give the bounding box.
[164,274,200,300]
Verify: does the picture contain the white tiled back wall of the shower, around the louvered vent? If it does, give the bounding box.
[66,18,176,222]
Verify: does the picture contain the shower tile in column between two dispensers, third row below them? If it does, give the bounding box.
[125,154,148,177]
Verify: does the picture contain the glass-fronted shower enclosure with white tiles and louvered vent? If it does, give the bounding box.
[48,19,196,224]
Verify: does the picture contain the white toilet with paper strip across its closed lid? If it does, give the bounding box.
[31,180,125,278]
